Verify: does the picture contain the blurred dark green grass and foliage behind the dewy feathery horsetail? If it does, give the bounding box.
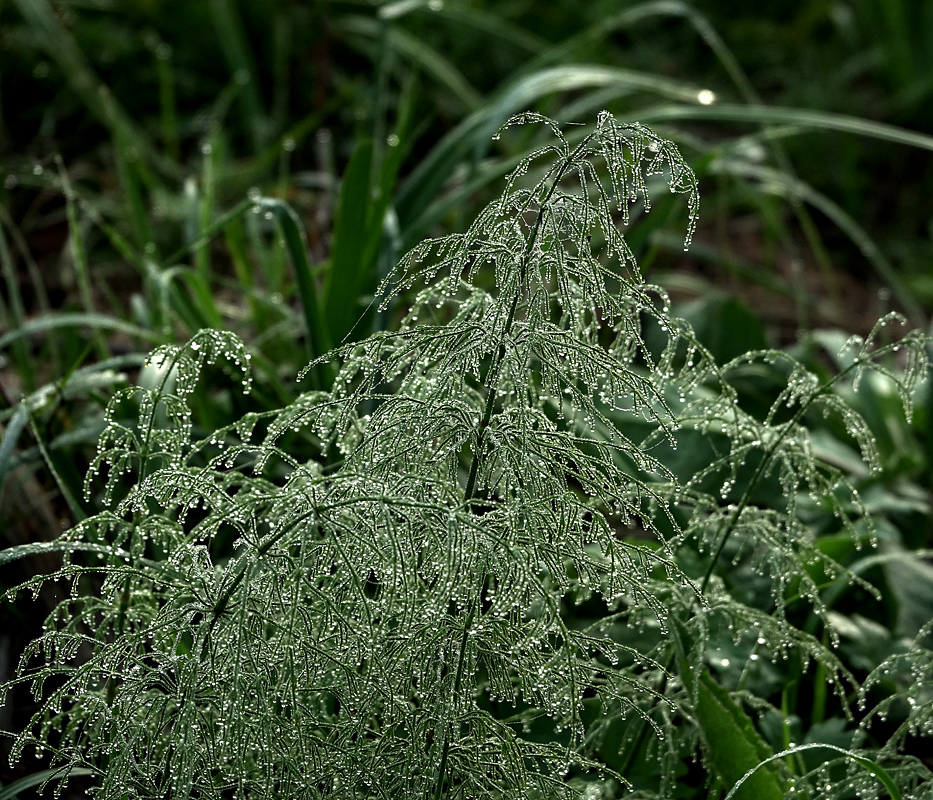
[0,0,933,796]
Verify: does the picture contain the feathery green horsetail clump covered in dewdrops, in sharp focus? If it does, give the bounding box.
[0,113,933,800]
